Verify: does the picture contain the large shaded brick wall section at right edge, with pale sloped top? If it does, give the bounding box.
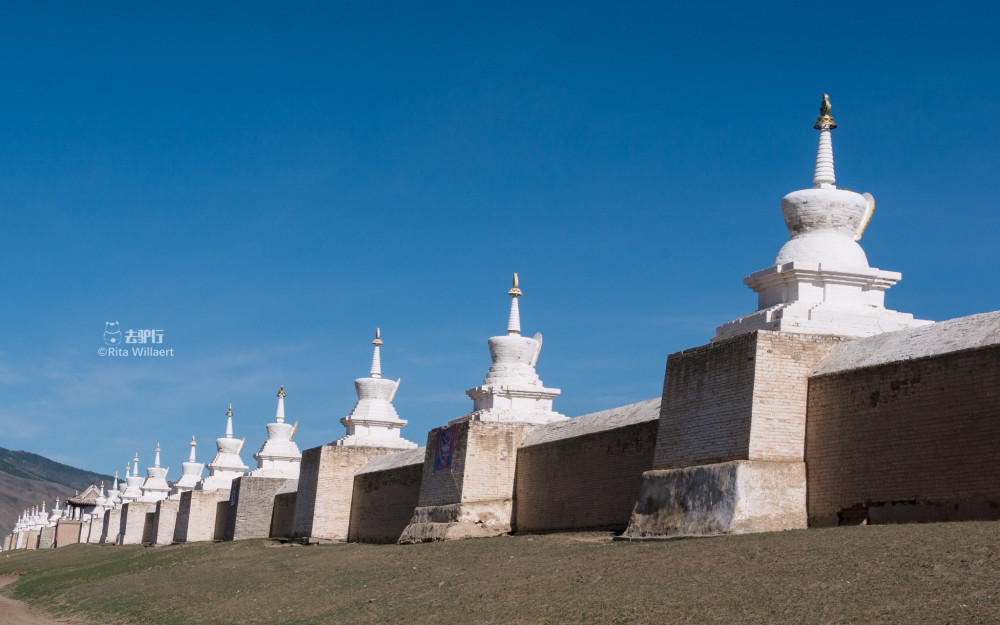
[806,312,1000,526]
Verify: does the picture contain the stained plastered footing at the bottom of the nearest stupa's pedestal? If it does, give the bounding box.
[623,460,806,539]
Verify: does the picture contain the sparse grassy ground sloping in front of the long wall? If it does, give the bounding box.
[0,522,1000,625]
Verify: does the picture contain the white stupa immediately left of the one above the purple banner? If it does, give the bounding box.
[330,328,417,449]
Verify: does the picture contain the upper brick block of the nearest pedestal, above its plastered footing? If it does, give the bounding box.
[654,331,842,469]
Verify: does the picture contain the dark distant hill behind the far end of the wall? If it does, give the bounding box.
[0,447,112,536]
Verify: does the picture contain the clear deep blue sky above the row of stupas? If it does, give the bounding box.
[0,2,1000,478]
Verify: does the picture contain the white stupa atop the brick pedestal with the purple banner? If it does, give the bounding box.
[450,273,568,424]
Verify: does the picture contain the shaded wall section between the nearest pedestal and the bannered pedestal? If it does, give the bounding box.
[514,398,660,531]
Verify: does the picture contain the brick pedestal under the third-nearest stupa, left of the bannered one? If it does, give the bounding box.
[292,445,399,540]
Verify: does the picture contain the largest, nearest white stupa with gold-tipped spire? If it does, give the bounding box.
[715,94,932,340]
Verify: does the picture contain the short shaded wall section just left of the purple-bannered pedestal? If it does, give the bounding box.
[347,447,427,543]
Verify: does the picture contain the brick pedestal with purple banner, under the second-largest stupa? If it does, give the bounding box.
[399,421,537,543]
